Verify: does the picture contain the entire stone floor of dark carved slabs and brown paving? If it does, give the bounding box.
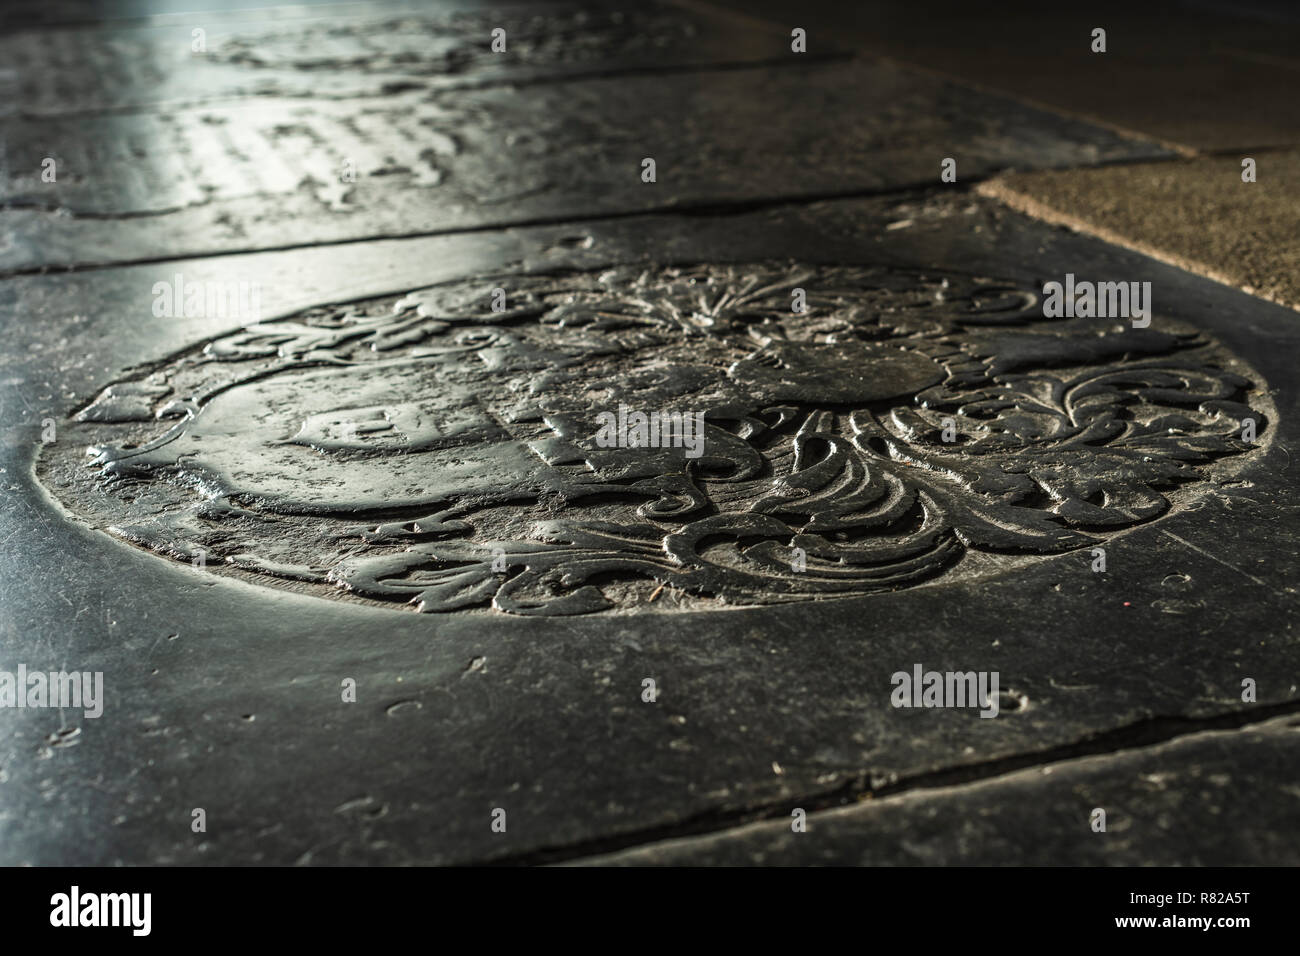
[0,0,1300,865]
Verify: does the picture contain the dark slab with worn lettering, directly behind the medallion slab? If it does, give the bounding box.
[0,32,1166,272]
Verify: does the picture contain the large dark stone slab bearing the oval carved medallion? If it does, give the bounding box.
[0,195,1300,865]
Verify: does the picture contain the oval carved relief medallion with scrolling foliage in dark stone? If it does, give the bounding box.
[39,263,1268,614]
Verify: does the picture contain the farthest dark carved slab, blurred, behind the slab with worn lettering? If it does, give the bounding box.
[0,0,800,116]
